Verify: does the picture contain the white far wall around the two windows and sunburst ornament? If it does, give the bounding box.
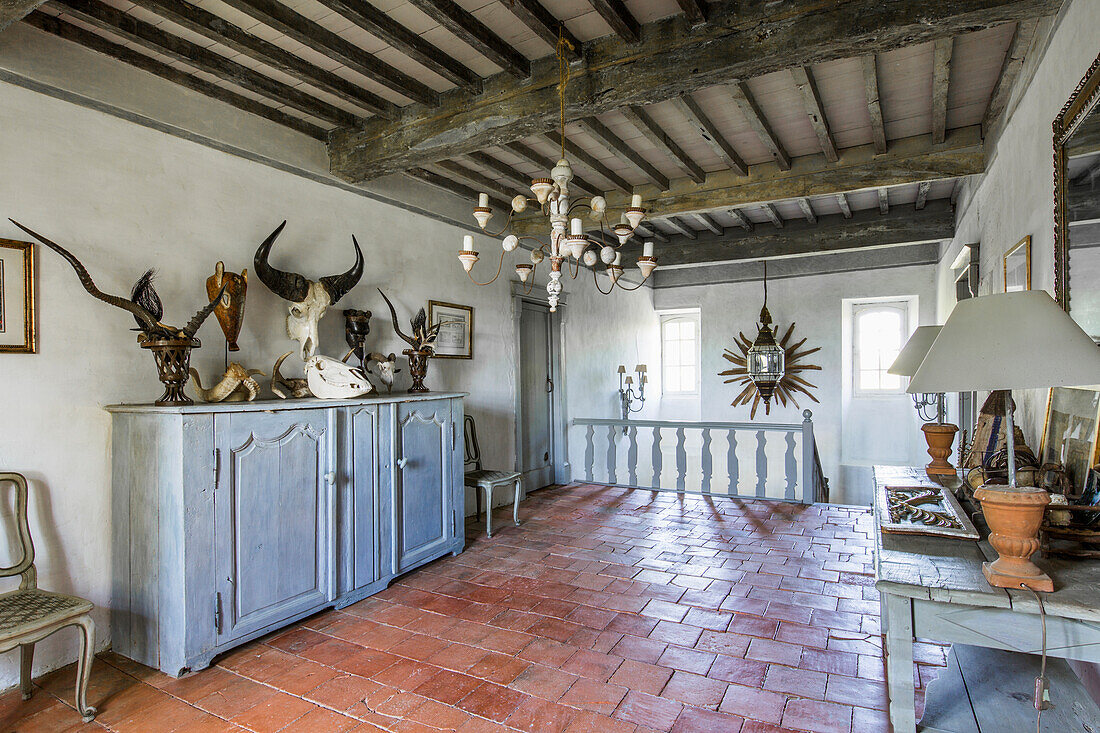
[655,265,936,504]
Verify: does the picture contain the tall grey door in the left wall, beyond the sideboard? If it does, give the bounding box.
[519,303,556,490]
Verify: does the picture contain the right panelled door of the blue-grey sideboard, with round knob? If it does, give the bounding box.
[393,400,455,572]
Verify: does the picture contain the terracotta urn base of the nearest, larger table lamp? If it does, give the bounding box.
[974,484,1054,592]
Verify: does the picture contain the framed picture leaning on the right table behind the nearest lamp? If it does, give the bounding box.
[1040,387,1100,493]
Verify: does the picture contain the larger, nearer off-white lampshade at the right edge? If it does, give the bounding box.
[908,291,1100,394]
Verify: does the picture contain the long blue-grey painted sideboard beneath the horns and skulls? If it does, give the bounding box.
[107,393,464,676]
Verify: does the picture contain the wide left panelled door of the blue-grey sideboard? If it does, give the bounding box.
[215,409,336,645]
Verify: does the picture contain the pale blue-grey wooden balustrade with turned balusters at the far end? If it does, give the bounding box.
[572,409,828,503]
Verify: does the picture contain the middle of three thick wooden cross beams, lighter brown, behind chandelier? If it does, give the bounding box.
[517,125,986,234]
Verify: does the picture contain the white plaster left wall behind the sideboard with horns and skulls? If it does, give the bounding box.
[0,84,534,688]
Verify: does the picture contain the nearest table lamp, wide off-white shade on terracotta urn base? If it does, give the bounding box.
[908,291,1100,591]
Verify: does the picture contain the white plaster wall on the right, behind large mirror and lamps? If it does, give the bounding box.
[936,0,1100,442]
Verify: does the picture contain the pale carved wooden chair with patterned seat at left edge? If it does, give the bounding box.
[0,473,96,723]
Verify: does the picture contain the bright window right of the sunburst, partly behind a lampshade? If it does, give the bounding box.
[851,300,909,396]
